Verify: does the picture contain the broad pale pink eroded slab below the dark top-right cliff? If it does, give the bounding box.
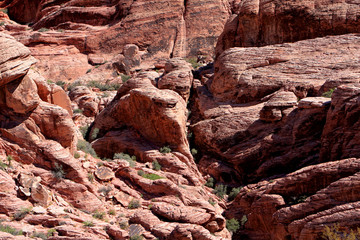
[210,34,360,103]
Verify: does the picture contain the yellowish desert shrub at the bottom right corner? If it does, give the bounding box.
[321,224,360,240]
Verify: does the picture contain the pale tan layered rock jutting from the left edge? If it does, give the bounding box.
[0,33,35,86]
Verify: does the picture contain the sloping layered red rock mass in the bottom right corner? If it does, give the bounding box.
[227,158,360,240]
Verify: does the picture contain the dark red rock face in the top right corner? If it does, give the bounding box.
[216,0,360,55]
